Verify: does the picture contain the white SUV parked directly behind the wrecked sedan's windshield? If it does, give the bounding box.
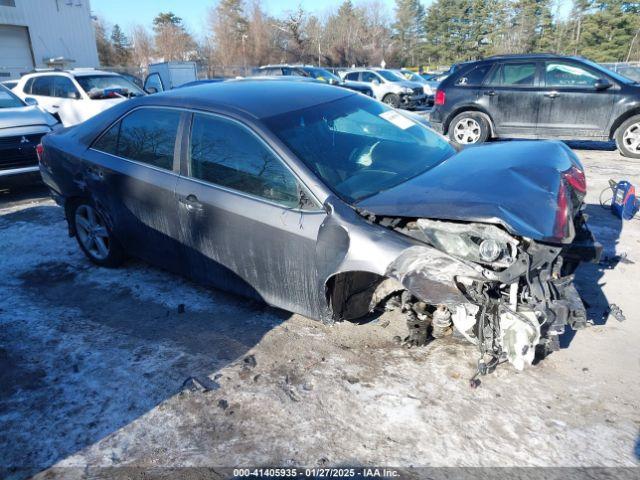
[342,69,427,108]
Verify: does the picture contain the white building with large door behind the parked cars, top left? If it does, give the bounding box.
[0,0,99,81]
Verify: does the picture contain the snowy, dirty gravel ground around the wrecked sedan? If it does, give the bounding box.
[0,143,640,478]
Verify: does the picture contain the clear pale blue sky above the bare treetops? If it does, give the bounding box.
[91,0,398,35]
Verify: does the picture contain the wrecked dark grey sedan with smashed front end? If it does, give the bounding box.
[41,79,598,368]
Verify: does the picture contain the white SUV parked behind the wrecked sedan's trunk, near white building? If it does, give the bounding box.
[13,69,145,127]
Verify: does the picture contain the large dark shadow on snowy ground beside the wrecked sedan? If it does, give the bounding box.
[0,200,290,479]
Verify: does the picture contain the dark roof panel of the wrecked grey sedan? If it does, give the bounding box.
[136,78,357,119]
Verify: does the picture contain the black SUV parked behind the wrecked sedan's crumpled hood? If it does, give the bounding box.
[430,54,640,158]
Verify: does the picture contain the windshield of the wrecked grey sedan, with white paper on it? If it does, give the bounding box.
[265,95,455,203]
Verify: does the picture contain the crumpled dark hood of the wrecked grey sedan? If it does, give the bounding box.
[356,141,584,242]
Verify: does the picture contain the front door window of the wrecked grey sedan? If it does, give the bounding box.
[189,114,299,208]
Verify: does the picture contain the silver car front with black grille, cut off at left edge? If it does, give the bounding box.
[0,85,60,185]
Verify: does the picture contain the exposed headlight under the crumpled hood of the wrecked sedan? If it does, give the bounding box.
[416,219,518,267]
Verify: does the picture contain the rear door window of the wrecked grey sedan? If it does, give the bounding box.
[93,108,180,170]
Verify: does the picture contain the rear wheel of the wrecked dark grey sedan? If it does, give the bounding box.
[71,200,125,268]
